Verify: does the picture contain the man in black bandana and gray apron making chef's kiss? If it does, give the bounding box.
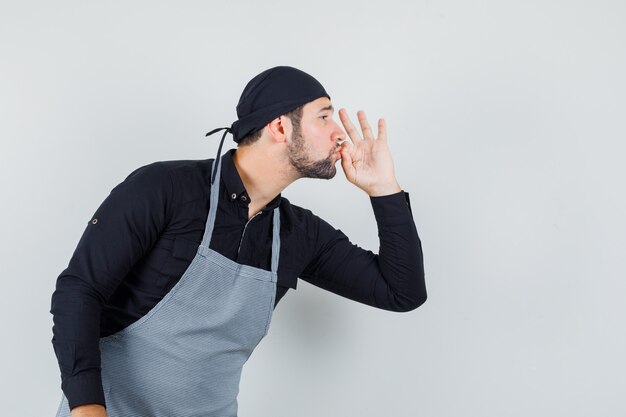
[51,66,426,417]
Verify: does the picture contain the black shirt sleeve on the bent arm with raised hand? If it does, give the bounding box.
[300,191,426,312]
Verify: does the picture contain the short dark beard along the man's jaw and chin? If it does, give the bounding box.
[287,128,339,180]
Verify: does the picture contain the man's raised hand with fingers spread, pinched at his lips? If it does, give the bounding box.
[339,108,401,197]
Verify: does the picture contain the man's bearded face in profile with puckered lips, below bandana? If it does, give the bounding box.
[287,97,345,179]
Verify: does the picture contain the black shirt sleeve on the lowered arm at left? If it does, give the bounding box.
[50,162,173,409]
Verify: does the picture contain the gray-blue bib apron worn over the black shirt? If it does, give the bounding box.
[57,157,280,417]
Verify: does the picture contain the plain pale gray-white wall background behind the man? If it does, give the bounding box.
[0,0,626,417]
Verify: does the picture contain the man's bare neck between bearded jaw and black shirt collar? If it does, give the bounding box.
[233,144,298,218]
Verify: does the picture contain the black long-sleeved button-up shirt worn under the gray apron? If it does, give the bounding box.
[51,150,426,408]
